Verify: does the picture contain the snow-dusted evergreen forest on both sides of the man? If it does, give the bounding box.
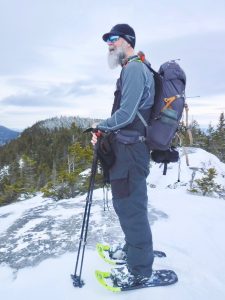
[0,112,225,205]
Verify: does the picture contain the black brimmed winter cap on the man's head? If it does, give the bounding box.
[102,24,136,48]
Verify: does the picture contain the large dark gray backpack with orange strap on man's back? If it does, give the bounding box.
[137,52,186,174]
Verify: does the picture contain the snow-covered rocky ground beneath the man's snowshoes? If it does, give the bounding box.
[0,149,225,300]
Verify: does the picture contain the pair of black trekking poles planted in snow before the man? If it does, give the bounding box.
[71,130,99,288]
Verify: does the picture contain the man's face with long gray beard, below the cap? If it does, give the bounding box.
[107,37,128,69]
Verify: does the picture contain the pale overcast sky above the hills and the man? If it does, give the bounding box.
[0,0,225,129]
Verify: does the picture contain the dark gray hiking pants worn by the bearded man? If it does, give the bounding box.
[110,141,153,276]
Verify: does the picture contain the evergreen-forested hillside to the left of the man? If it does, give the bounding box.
[0,118,95,203]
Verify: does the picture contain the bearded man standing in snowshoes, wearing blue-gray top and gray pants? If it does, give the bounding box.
[92,24,155,286]
